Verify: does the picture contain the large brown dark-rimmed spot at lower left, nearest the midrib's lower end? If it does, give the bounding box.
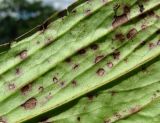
[22,98,37,110]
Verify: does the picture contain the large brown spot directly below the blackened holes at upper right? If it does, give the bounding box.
[112,14,128,28]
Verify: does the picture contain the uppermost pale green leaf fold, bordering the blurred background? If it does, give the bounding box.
[0,0,113,74]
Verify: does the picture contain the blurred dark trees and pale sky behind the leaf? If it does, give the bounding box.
[0,0,75,44]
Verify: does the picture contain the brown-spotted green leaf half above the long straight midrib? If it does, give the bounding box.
[0,0,160,123]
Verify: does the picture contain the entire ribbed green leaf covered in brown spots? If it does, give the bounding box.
[0,0,160,123]
